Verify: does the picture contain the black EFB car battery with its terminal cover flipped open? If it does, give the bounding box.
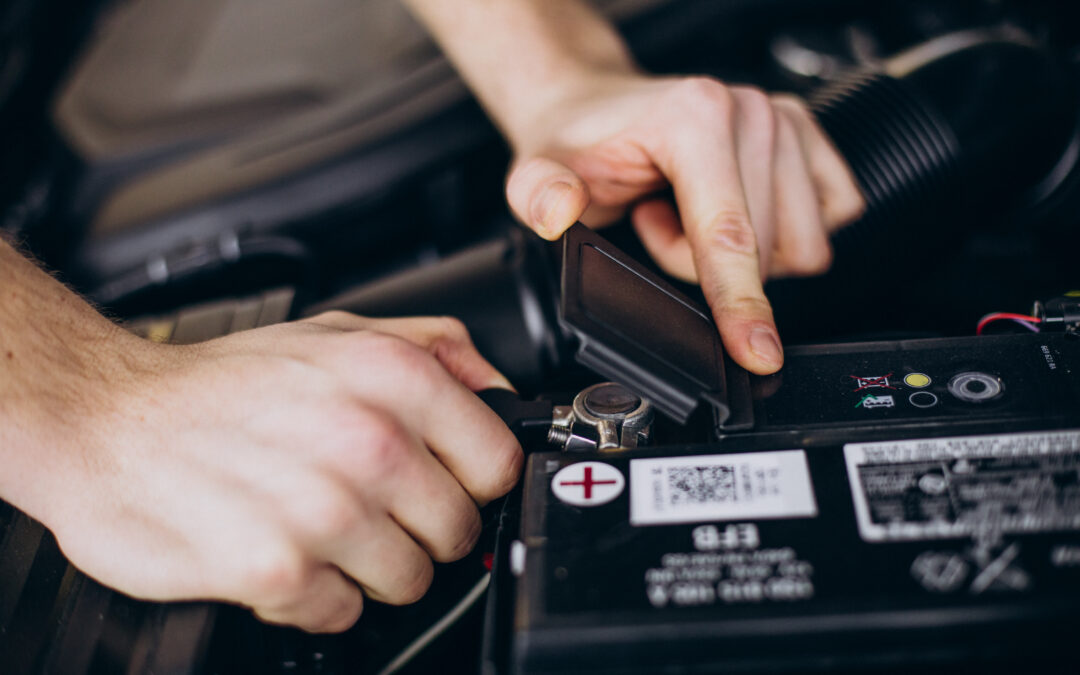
[485,226,1080,675]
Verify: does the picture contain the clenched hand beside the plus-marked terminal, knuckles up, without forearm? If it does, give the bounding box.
[38,312,522,632]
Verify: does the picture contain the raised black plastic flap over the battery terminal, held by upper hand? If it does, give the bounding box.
[559,224,751,427]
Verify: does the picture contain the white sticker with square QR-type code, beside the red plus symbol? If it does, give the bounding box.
[630,450,818,525]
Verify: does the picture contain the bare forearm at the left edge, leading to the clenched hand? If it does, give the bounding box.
[0,240,139,519]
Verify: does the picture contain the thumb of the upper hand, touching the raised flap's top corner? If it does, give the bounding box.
[507,157,589,240]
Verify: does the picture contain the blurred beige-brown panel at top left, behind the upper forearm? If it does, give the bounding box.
[55,0,665,233]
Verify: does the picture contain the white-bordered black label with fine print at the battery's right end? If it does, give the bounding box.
[843,431,1080,541]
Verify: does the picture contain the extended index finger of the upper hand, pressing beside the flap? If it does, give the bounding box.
[651,83,783,375]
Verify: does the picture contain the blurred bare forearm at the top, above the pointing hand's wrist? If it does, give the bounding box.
[404,0,635,144]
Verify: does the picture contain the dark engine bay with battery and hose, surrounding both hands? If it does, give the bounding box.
[0,0,1080,675]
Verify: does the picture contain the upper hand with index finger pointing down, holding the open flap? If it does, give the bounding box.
[507,75,864,375]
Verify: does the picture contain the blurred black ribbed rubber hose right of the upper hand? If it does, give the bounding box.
[810,33,1078,264]
